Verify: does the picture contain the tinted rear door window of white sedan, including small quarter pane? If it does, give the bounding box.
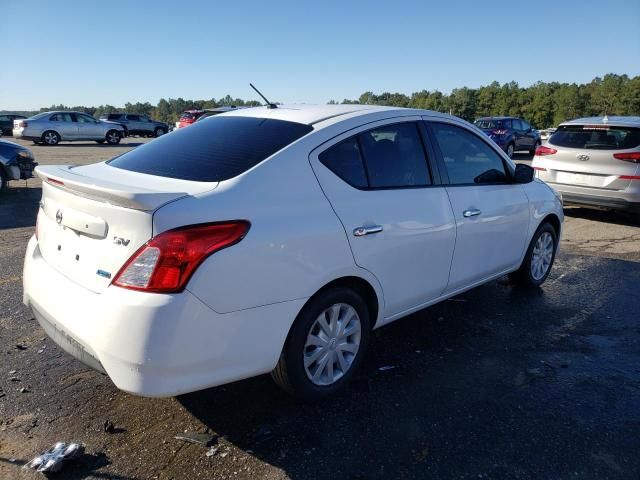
[318,123,431,189]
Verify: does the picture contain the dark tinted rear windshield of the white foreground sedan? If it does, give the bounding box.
[107,115,313,182]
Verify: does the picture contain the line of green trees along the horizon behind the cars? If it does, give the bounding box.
[3,73,640,128]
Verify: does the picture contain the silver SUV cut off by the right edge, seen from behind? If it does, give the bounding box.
[532,117,640,212]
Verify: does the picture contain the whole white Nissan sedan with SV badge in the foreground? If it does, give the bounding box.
[24,105,563,399]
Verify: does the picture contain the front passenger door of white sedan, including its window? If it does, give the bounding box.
[428,121,529,292]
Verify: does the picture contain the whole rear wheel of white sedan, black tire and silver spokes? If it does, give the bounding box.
[271,287,371,401]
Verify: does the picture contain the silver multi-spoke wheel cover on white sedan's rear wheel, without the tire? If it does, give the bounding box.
[303,303,362,386]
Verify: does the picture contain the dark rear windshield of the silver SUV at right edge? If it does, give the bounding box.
[549,125,640,150]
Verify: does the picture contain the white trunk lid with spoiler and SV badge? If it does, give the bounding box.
[36,163,217,293]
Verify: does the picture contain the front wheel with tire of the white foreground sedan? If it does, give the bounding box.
[509,222,558,288]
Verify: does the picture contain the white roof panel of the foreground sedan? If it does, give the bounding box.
[223,104,449,125]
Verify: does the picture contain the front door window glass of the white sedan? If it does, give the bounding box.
[431,123,508,185]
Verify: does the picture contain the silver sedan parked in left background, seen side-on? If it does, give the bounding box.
[13,111,124,145]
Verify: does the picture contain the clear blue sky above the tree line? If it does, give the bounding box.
[0,0,640,110]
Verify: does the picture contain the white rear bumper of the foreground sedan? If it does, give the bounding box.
[23,237,304,397]
